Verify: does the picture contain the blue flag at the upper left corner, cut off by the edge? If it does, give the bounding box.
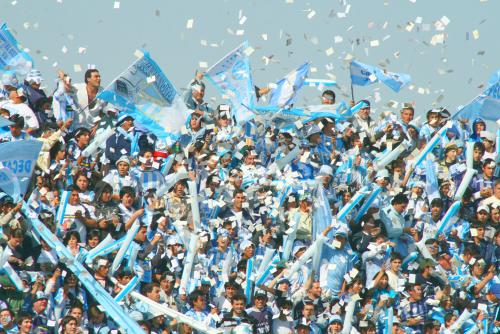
[0,23,33,75]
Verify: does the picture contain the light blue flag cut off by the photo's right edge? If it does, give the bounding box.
[452,70,500,121]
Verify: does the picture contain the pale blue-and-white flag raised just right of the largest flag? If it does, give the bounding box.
[205,42,255,124]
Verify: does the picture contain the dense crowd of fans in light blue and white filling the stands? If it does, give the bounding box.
[0,63,500,334]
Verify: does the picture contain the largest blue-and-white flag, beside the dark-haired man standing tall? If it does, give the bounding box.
[97,51,189,139]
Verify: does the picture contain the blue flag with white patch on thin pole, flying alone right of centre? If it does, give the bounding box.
[350,60,411,93]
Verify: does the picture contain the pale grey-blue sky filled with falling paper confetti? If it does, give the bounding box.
[0,0,500,121]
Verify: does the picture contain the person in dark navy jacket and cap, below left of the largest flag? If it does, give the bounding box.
[106,114,134,166]
